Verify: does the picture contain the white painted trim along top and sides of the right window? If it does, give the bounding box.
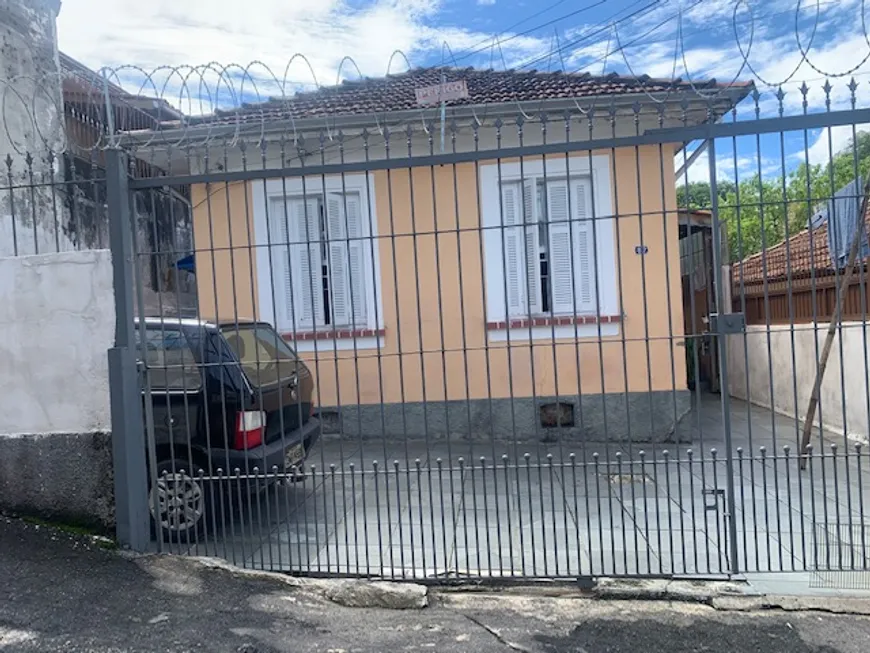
[480,154,619,332]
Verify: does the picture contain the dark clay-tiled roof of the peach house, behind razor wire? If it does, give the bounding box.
[194,67,752,123]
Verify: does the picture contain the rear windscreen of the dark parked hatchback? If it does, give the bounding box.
[221,324,298,387]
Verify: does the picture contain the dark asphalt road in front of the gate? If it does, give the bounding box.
[0,519,870,653]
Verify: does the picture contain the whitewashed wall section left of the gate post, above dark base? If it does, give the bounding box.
[0,250,115,437]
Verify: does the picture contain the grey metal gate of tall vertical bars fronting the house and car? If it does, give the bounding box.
[95,77,868,582]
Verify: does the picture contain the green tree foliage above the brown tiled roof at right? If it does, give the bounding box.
[677,132,870,262]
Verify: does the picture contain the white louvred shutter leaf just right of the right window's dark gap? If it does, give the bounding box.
[547,181,579,315]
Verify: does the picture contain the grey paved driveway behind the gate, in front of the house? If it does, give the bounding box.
[158,398,870,586]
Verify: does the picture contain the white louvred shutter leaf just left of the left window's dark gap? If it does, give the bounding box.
[289,199,324,329]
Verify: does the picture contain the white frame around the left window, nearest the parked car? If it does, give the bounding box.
[251,174,384,352]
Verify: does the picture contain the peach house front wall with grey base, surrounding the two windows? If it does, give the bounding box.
[192,146,688,440]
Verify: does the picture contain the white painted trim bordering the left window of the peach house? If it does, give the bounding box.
[250,174,384,351]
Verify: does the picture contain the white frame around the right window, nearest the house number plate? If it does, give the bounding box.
[480,155,619,340]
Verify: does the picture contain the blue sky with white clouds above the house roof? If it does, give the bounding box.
[58,0,870,186]
